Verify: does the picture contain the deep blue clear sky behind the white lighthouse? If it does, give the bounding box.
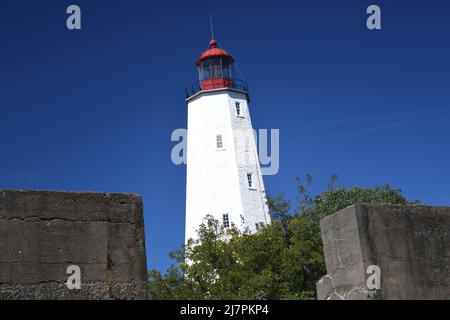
[0,0,450,269]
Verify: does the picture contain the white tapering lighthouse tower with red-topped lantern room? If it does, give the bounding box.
[185,39,270,242]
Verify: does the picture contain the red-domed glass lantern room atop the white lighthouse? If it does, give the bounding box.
[196,39,234,90]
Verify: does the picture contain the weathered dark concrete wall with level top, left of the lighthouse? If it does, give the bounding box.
[0,190,147,299]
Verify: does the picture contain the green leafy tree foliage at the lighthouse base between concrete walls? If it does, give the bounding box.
[148,175,416,299]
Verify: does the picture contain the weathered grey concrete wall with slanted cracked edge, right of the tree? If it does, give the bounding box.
[317,204,450,299]
